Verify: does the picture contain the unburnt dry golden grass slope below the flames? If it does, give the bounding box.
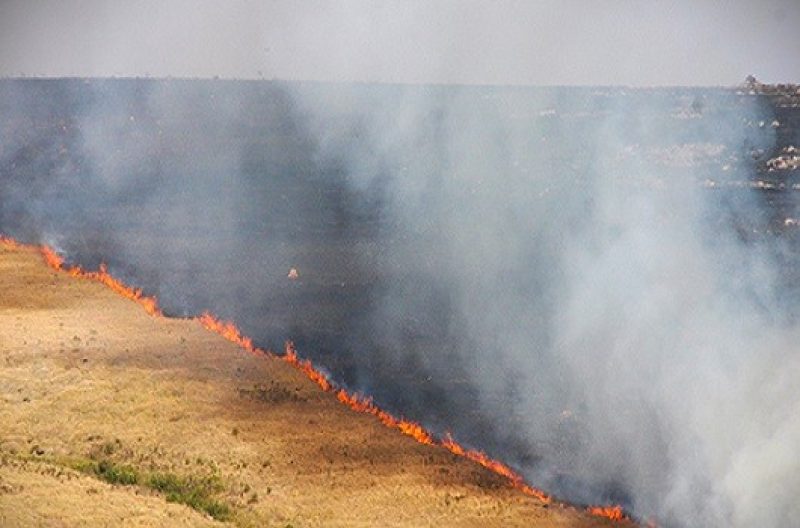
[0,245,611,527]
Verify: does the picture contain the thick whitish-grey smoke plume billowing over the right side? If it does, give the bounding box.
[290,84,800,526]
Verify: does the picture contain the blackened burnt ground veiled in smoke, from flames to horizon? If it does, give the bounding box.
[0,79,800,526]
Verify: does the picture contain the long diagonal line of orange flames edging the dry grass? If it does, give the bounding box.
[0,235,628,521]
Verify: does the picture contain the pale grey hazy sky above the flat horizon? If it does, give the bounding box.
[0,0,800,85]
